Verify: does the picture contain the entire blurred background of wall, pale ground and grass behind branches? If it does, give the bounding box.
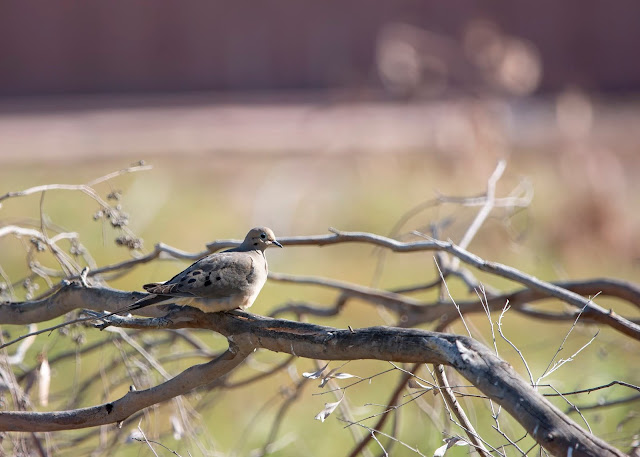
[0,1,640,455]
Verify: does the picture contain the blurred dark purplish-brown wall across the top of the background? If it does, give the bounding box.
[0,0,640,95]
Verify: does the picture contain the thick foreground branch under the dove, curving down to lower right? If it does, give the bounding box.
[101,308,623,457]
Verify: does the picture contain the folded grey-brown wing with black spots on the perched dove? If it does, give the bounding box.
[143,252,266,299]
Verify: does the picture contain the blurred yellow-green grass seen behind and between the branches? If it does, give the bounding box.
[0,151,640,456]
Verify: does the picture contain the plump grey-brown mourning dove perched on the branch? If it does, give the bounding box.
[130,227,282,313]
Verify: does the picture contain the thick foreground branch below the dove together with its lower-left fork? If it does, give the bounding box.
[0,300,623,457]
